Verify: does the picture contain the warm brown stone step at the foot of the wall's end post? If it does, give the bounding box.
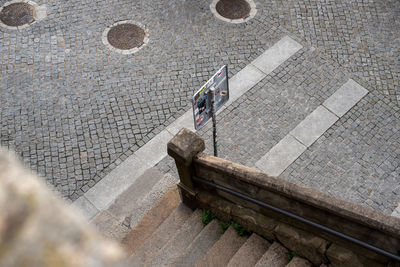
[121,182,180,254]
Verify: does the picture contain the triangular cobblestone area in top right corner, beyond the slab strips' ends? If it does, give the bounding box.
[266,0,400,104]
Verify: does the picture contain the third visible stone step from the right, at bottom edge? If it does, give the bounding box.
[227,233,271,267]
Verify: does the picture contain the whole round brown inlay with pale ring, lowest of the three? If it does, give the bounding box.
[102,20,149,54]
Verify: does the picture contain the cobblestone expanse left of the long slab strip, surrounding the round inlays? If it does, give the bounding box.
[0,0,282,199]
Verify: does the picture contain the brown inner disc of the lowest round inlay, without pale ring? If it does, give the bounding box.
[107,23,146,50]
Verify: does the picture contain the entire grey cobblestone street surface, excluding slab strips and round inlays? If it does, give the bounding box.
[0,0,400,216]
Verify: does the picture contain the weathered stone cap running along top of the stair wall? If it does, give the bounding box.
[195,153,400,238]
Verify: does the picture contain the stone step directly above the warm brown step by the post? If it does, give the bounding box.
[135,203,193,262]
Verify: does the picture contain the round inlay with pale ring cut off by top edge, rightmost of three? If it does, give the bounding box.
[210,0,257,23]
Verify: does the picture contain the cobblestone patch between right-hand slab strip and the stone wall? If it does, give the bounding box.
[281,94,400,214]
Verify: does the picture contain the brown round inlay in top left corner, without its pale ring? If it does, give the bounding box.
[0,2,35,27]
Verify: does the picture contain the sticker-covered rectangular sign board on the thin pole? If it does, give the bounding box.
[192,66,229,130]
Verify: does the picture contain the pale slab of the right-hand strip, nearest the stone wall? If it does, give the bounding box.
[255,135,307,176]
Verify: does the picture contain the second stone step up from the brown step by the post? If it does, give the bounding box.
[147,209,203,266]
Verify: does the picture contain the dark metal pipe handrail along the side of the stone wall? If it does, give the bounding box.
[193,177,400,262]
